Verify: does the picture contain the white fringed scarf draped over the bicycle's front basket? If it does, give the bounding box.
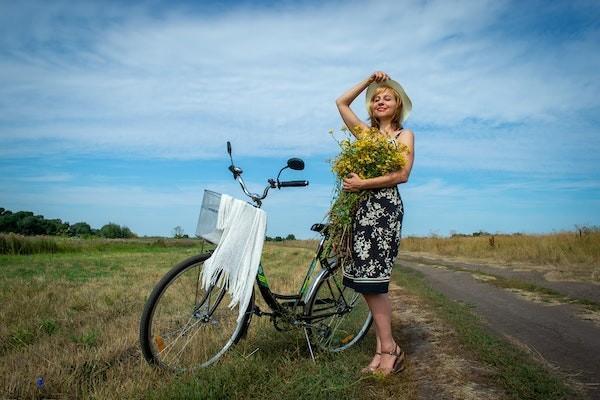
[200,194,267,322]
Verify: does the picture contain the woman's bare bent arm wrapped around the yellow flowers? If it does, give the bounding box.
[343,129,415,192]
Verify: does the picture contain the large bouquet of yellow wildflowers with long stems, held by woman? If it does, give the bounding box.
[328,126,408,262]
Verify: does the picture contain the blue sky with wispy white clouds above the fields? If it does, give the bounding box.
[0,0,600,238]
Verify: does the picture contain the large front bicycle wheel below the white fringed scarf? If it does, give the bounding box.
[140,254,254,371]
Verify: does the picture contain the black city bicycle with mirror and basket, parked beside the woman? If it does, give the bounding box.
[139,142,372,371]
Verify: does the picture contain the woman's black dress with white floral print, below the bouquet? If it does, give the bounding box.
[343,137,404,293]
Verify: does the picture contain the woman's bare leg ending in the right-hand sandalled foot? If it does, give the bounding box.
[364,293,396,369]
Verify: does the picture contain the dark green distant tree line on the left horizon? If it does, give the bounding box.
[0,207,137,239]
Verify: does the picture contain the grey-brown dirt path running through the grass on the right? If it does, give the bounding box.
[398,253,600,399]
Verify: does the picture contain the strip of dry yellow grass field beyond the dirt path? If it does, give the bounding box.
[400,232,600,282]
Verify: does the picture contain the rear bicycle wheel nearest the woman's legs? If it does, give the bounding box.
[307,268,373,352]
